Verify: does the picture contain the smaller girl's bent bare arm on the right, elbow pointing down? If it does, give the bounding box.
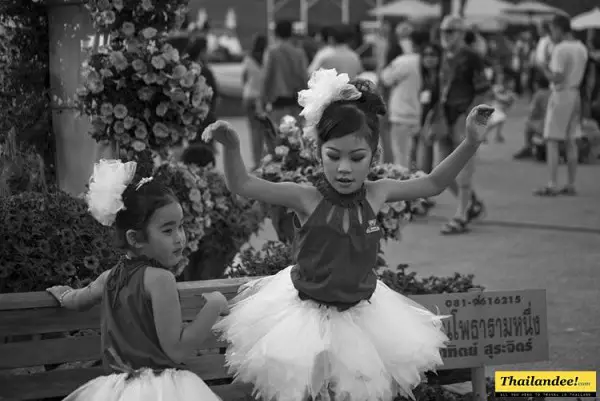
[144,268,228,363]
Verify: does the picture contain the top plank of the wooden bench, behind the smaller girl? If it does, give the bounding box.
[0,278,249,311]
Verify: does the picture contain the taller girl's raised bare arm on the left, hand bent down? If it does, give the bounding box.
[203,121,312,214]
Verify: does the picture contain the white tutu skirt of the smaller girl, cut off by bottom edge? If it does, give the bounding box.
[64,369,221,401]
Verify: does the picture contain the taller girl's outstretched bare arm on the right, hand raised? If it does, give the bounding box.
[373,105,494,202]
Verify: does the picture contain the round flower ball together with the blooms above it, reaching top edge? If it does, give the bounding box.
[78,0,212,160]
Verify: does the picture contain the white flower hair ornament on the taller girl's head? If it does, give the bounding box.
[298,69,362,139]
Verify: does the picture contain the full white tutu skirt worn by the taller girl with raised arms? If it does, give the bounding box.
[215,266,447,401]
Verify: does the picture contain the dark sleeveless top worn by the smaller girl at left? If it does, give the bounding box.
[101,258,182,373]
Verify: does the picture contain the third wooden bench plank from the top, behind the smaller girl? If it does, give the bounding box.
[0,335,227,369]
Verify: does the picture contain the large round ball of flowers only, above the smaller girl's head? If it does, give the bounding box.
[78,38,212,160]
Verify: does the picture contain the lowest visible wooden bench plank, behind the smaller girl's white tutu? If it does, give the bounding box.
[0,355,231,401]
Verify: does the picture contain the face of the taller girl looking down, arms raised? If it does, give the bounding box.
[321,134,373,194]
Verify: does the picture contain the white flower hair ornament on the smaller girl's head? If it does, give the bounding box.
[85,159,137,226]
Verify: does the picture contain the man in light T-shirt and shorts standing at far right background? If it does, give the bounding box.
[534,15,588,196]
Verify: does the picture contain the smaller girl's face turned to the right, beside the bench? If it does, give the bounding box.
[131,202,186,268]
